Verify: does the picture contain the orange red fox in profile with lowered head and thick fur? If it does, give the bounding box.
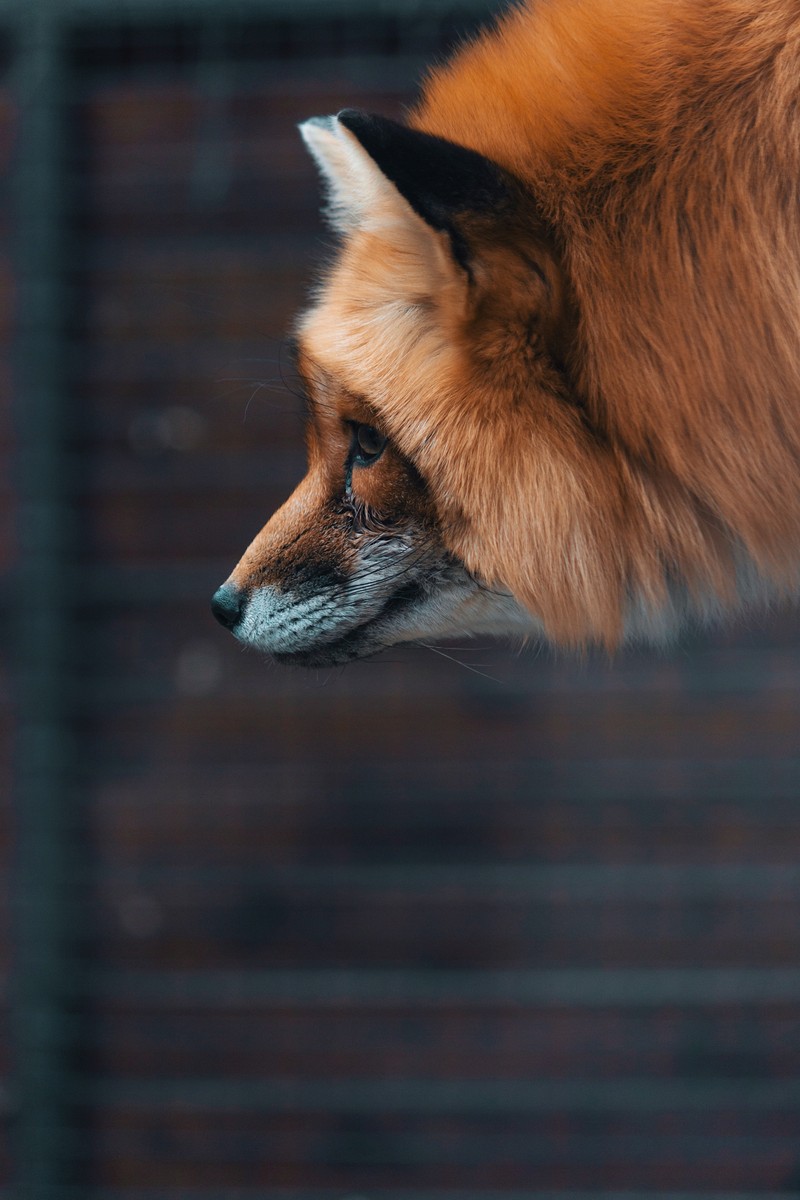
[212,0,800,666]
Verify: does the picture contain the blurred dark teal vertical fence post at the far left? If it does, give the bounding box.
[12,7,74,1200]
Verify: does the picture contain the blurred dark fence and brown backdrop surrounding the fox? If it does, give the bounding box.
[0,0,800,1200]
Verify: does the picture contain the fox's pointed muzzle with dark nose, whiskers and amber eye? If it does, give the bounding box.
[211,434,475,666]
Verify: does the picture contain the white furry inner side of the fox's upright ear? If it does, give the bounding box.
[300,116,419,233]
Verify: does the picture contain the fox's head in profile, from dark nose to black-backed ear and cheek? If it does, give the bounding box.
[213,110,724,665]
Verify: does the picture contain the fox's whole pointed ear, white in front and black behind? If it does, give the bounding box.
[300,108,511,258]
